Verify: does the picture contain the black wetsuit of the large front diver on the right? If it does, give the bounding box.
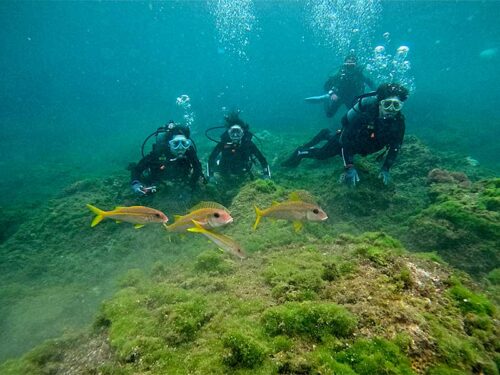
[299,97,405,170]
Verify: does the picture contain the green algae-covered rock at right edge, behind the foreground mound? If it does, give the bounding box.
[410,179,500,275]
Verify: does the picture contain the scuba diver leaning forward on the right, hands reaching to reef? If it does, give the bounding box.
[280,83,408,186]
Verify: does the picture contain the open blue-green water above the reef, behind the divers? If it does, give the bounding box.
[0,1,500,204]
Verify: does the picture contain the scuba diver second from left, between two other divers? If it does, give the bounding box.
[205,111,271,182]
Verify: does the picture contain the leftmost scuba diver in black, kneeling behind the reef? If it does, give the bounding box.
[129,121,205,196]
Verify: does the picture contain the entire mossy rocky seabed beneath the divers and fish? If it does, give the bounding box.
[0,133,499,374]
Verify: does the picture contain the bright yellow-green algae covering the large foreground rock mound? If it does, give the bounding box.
[0,229,498,374]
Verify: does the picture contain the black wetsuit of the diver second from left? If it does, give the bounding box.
[207,131,269,177]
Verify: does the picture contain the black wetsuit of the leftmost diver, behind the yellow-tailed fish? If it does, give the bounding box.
[131,143,203,187]
